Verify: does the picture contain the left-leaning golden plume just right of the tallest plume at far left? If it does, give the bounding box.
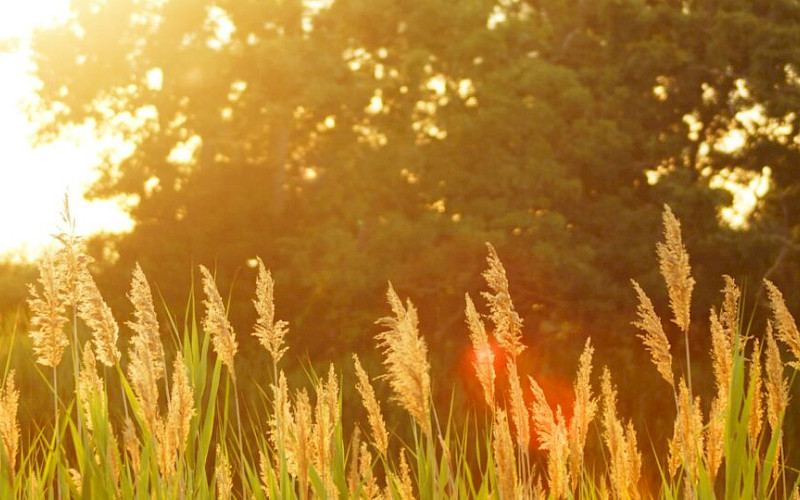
[78,266,120,367]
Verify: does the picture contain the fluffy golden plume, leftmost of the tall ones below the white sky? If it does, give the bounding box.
[28,254,69,367]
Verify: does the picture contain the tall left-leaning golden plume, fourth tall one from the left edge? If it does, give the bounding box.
[126,262,166,382]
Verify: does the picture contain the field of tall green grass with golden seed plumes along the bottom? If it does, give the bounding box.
[0,207,800,499]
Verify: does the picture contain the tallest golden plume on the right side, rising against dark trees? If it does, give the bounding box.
[656,205,695,332]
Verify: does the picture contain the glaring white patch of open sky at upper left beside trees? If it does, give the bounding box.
[0,0,132,260]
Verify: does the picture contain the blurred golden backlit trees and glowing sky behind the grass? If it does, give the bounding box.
[0,0,800,470]
